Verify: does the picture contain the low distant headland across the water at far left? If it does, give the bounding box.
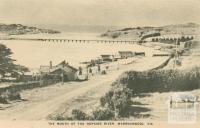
[0,24,60,35]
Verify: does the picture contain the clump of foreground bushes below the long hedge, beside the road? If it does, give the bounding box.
[55,86,132,120]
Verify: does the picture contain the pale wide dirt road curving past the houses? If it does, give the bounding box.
[0,57,168,120]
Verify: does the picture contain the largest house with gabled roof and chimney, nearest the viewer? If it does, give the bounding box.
[40,61,78,81]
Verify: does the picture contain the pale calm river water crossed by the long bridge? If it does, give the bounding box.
[0,33,155,68]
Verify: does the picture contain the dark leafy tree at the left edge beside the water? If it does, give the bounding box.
[0,44,28,77]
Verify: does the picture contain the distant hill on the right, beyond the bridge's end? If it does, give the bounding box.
[101,23,200,40]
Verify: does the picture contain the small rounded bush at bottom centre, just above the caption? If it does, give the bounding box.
[93,109,114,120]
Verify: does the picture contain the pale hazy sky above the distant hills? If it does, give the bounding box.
[0,0,200,26]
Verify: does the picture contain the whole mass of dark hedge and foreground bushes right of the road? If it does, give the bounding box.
[54,68,200,120]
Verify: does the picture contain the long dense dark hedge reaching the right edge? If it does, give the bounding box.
[113,68,200,93]
